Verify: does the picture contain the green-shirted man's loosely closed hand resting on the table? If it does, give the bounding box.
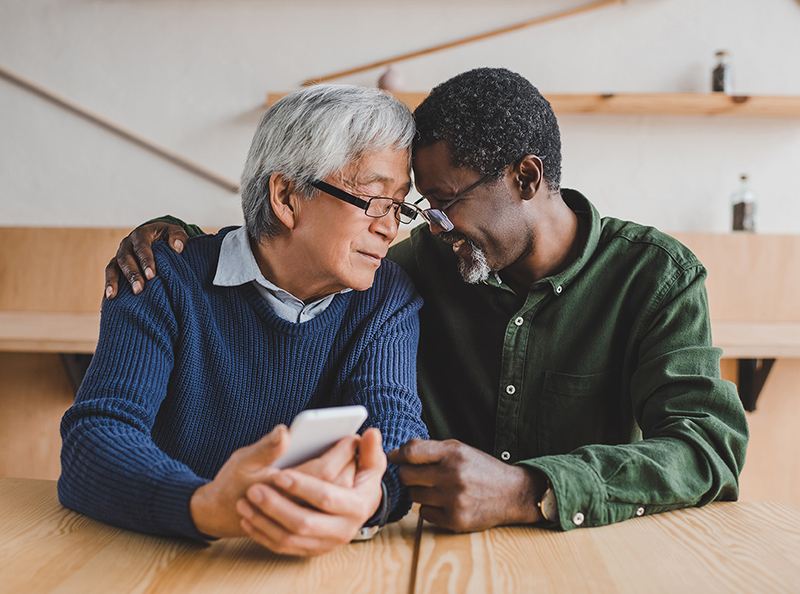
[389,439,546,532]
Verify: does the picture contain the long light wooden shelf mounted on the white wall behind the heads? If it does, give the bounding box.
[267,93,800,118]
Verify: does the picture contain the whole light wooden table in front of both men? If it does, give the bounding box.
[0,478,800,594]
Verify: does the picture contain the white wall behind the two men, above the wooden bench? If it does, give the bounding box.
[0,0,800,233]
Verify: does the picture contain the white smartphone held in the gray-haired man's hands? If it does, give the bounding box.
[272,404,367,468]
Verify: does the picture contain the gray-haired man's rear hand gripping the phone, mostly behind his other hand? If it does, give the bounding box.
[190,425,359,538]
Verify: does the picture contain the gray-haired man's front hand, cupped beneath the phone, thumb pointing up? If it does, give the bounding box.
[237,428,386,555]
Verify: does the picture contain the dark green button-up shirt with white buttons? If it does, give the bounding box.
[389,190,747,530]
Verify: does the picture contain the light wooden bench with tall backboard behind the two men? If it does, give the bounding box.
[0,227,800,410]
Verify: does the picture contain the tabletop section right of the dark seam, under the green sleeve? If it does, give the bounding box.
[415,503,800,594]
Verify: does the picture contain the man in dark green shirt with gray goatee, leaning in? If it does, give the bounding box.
[103,68,747,531]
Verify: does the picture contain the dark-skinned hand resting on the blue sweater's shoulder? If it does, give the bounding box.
[105,223,189,299]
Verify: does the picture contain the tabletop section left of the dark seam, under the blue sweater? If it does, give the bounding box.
[0,478,416,594]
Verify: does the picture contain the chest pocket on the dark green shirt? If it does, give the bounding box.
[537,371,620,455]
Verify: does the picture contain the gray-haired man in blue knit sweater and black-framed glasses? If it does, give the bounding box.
[58,85,427,555]
